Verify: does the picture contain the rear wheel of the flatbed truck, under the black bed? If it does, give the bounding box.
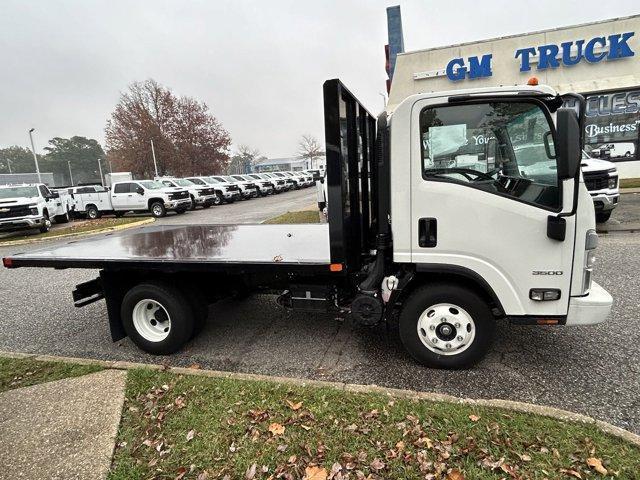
[120,282,195,355]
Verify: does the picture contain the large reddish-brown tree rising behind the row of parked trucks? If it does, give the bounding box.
[105,79,231,177]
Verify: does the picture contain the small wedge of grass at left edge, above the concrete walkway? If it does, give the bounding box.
[0,357,102,392]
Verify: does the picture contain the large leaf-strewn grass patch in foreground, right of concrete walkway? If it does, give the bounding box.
[109,370,640,480]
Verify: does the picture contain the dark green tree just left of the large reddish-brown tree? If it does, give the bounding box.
[40,136,109,185]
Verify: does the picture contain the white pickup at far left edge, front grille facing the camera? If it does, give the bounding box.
[0,183,70,233]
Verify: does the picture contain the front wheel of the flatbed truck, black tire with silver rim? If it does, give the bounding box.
[399,283,495,369]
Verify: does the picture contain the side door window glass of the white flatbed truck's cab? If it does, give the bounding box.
[420,101,560,208]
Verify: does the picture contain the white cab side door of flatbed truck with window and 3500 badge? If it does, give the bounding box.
[410,98,575,317]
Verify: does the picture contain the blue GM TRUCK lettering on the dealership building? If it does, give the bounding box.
[445,32,635,81]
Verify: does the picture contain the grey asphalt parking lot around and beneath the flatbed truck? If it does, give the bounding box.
[0,189,640,433]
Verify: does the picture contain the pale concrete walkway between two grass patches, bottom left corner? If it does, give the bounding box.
[0,370,127,480]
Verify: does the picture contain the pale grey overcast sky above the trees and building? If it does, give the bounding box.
[0,0,640,158]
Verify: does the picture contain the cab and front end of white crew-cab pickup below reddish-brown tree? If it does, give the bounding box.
[111,180,191,218]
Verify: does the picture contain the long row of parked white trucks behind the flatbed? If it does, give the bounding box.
[0,170,321,233]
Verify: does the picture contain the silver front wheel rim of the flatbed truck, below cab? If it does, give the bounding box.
[418,303,476,355]
